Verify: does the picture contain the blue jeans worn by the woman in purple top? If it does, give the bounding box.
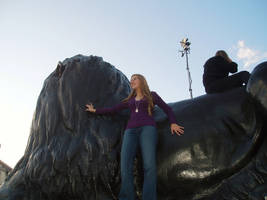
[119,126,158,200]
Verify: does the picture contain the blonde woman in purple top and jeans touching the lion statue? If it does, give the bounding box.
[86,74,184,200]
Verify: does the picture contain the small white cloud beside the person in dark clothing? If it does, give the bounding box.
[235,40,267,69]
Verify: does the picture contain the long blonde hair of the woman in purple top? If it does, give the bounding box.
[122,74,154,116]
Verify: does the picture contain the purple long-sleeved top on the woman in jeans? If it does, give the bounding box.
[95,91,177,129]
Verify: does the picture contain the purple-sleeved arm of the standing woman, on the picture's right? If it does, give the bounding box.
[151,91,177,124]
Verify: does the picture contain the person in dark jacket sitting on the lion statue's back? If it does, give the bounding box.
[203,50,250,94]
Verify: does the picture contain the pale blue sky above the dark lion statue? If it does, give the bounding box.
[0,0,267,167]
